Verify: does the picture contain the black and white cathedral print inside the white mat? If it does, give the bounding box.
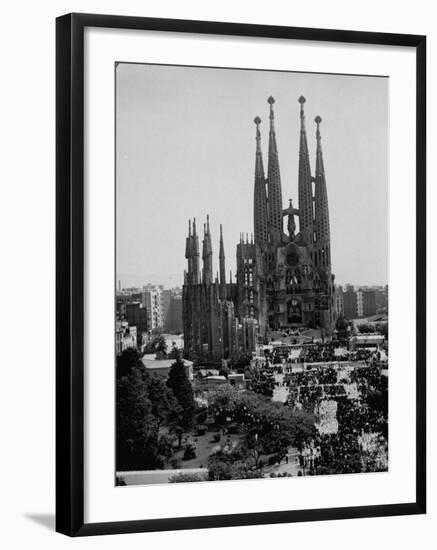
[115,62,389,486]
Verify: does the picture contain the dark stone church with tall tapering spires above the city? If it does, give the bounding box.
[182,96,335,361]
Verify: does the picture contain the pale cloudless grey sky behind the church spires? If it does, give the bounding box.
[116,63,389,287]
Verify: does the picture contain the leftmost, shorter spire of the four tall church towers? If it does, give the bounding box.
[253,116,268,246]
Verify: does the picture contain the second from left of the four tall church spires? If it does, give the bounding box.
[267,96,283,244]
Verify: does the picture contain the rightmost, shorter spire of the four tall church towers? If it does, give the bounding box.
[314,116,331,271]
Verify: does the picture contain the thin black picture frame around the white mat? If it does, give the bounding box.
[56,14,426,536]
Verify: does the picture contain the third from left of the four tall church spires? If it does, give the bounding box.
[298,96,313,244]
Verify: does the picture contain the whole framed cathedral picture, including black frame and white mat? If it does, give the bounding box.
[56,14,426,536]
